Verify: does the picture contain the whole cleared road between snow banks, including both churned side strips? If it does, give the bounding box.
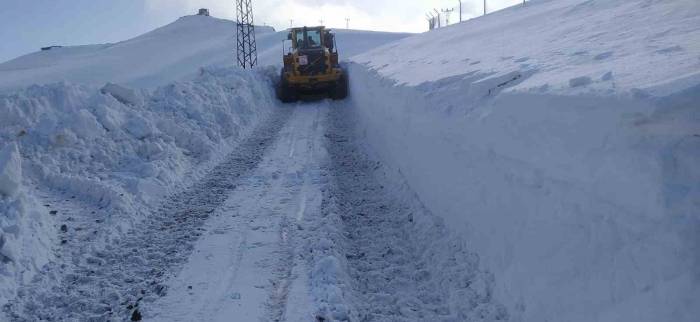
[5,101,500,322]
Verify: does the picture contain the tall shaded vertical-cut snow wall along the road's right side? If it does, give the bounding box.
[350,63,700,321]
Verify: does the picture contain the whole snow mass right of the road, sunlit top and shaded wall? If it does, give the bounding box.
[351,0,700,321]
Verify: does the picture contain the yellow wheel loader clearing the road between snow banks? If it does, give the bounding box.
[277,26,348,103]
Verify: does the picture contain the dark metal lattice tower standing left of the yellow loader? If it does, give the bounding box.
[236,0,258,68]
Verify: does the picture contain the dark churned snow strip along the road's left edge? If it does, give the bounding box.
[3,109,292,321]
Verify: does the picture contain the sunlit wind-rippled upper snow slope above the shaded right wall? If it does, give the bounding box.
[354,0,700,94]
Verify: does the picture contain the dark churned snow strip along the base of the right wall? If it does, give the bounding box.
[312,105,508,322]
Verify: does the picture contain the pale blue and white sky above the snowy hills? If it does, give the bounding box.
[0,0,522,62]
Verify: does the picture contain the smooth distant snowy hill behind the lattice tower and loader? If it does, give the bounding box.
[0,16,408,91]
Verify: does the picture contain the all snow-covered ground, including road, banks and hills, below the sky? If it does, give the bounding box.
[0,0,700,322]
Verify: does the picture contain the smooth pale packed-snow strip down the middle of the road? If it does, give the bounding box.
[148,104,327,322]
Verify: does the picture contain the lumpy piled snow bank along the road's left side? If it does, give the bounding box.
[0,68,277,303]
